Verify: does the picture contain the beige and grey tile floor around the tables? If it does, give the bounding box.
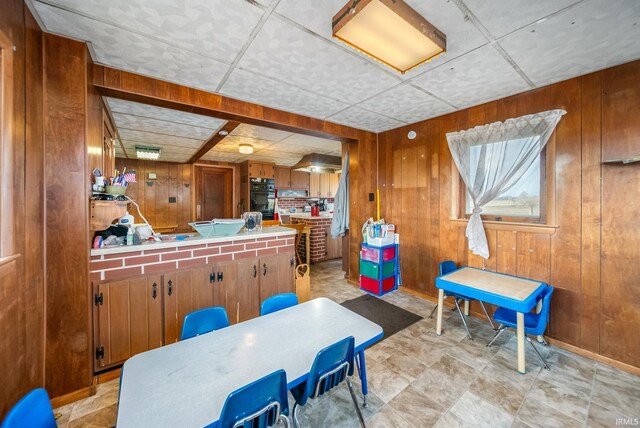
[56,262,640,428]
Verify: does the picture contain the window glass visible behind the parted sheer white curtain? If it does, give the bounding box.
[460,140,546,223]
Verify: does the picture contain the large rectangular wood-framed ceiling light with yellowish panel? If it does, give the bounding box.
[332,0,447,74]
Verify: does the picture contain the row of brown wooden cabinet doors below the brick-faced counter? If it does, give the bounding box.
[93,253,295,371]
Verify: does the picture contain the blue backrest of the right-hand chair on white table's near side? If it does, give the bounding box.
[298,336,355,406]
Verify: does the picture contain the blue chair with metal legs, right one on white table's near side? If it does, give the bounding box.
[291,336,365,427]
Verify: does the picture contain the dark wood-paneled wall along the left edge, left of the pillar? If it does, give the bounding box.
[0,0,44,419]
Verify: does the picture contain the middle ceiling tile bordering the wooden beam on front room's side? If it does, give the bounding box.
[220,69,347,119]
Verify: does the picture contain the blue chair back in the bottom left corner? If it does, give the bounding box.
[1,388,57,428]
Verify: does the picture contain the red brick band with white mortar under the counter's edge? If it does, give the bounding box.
[90,235,295,281]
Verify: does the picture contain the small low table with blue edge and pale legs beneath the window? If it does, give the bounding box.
[436,267,546,373]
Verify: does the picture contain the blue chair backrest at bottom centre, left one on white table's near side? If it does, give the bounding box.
[216,370,289,428]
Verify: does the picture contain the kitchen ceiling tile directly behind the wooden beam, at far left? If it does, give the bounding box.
[107,98,225,130]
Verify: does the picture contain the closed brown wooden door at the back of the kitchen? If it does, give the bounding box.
[195,166,233,221]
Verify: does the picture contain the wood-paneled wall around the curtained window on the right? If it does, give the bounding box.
[379,61,640,367]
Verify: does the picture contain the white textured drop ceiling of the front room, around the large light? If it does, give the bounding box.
[28,0,640,133]
